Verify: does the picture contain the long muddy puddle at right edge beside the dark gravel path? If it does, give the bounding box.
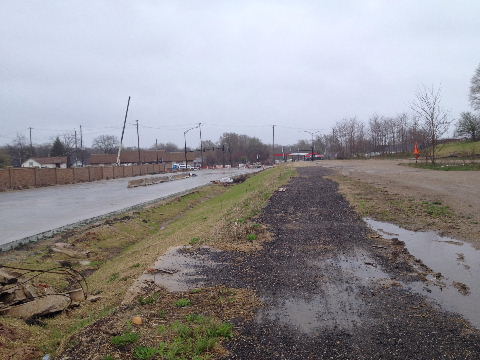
[364,219,480,329]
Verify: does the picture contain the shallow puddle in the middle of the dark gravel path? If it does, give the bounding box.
[256,250,390,336]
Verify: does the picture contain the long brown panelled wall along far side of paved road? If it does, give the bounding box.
[0,163,172,191]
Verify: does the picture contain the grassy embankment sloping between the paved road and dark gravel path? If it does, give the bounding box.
[0,167,295,359]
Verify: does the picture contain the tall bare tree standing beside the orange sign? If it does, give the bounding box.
[412,86,451,165]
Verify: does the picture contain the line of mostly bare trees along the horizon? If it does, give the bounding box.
[0,64,480,167]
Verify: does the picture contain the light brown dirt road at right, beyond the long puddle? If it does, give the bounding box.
[318,160,480,216]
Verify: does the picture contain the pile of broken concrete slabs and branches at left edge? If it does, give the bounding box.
[0,266,88,320]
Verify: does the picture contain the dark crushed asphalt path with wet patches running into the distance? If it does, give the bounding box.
[200,167,480,359]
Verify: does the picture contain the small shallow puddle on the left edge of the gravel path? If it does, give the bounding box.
[141,246,217,292]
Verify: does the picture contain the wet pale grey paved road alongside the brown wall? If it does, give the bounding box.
[0,169,255,248]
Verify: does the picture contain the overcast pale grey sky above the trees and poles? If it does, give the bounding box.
[0,0,480,146]
